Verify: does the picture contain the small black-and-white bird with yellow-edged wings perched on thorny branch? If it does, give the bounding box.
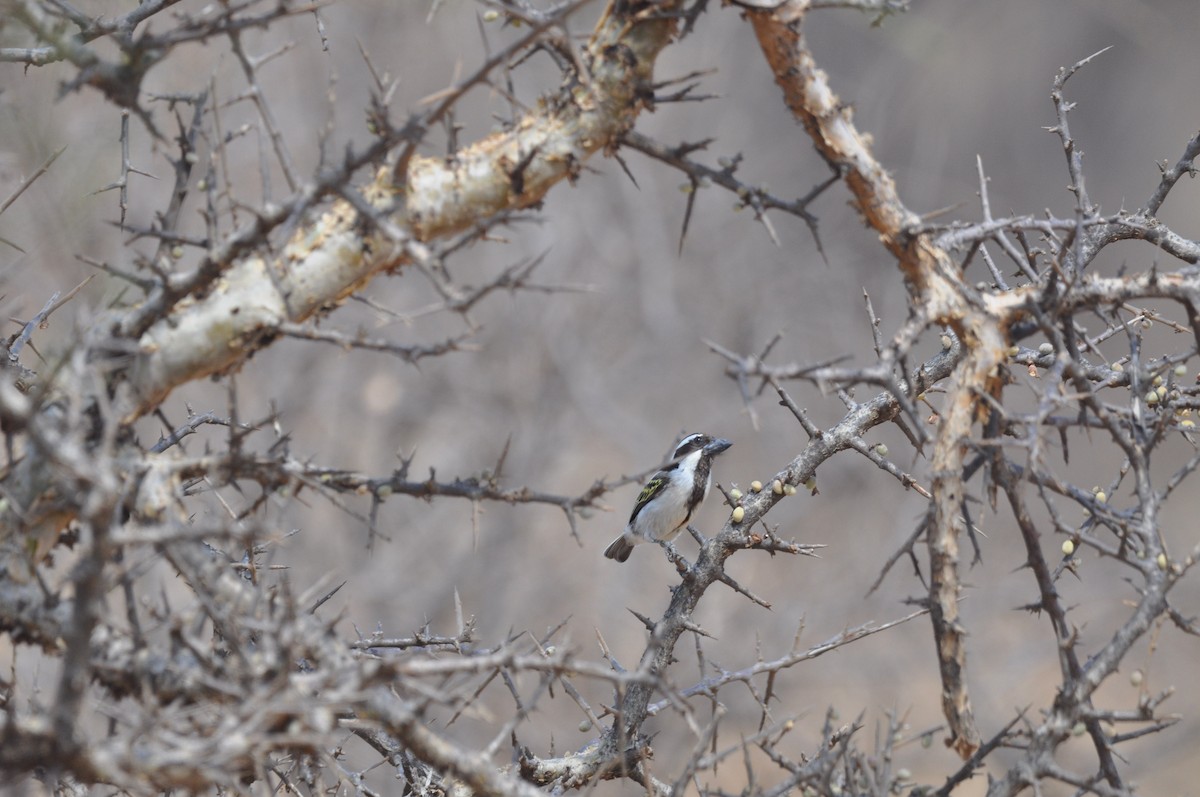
[604,435,733,562]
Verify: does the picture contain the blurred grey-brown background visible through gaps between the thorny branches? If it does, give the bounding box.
[0,0,1200,795]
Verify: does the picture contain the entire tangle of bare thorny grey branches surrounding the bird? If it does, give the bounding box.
[0,0,1200,797]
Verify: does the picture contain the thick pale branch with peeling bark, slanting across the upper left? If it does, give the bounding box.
[120,2,677,420]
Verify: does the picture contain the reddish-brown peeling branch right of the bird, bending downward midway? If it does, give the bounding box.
[746,0,1007,759]
